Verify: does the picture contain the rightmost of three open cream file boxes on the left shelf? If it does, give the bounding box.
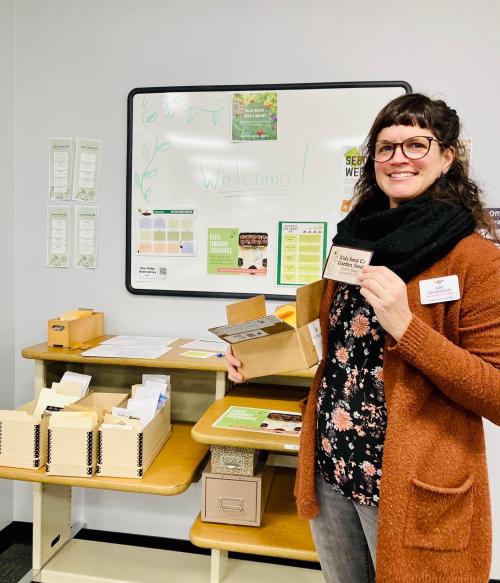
[97,399,172,478]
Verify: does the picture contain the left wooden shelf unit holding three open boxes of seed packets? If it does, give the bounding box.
[9,336,315,583]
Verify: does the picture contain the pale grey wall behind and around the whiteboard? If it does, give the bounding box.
[11,0,500,577]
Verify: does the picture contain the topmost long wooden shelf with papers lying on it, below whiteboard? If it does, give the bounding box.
[21,335,316,378]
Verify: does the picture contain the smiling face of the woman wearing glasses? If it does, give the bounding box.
[375,125,454,208]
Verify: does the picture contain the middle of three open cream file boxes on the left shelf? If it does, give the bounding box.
[46,393,128,477]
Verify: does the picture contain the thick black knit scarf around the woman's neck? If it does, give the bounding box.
[333,194,476,281]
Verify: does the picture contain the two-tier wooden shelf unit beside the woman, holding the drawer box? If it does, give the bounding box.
[190,385,318,583]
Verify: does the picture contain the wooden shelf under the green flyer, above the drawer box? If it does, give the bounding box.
[191,385,306,453]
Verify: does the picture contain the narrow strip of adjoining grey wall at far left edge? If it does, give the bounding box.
[0,0,15,530]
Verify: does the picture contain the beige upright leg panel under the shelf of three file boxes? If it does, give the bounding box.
[33,484,72,571]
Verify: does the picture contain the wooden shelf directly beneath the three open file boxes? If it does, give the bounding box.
[0,423,208,496]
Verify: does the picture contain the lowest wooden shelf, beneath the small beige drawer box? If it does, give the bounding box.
[189,468,318,562]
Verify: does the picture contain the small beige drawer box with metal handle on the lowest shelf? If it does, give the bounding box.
[201,463,274,526]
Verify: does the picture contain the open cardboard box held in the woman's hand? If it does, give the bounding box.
[210,280,325,379]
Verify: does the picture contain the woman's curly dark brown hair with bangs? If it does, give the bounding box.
[354,93,499,242]
